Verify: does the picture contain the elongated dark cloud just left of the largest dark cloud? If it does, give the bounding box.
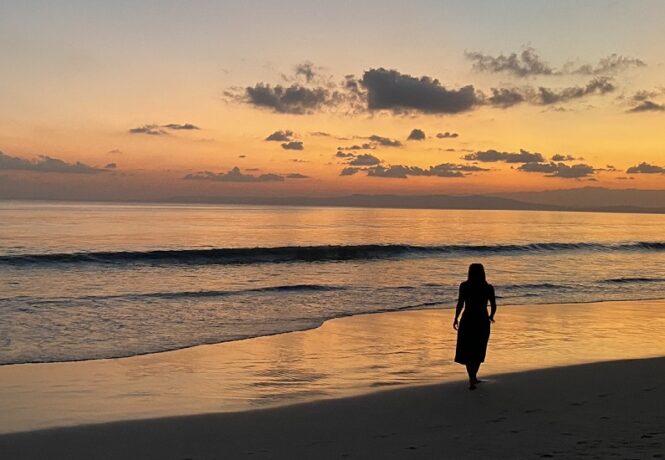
[245,83,332,115]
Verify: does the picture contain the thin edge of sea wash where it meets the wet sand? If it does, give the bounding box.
[5,297,665,369]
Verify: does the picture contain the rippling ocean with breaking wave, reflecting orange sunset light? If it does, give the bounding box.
[0,201,665,364]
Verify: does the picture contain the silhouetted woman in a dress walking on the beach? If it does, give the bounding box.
[453,264,496,390]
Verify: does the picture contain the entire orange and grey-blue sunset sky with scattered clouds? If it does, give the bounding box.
[0,0,665,200]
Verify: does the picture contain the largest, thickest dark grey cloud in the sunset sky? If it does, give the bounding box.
[361,68,479,114]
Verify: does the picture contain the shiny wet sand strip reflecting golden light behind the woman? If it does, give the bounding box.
[0,300,665,433]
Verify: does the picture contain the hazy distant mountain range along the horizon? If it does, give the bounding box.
[164,187,665,213]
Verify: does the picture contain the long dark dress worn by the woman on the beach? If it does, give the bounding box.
[455,281,494,364]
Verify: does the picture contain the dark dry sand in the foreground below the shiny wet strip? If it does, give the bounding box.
[0,357,665,460]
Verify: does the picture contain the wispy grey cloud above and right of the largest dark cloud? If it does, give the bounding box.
[465,47,555,77]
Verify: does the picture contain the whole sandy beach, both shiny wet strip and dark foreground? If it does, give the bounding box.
[0,301,665,459]
